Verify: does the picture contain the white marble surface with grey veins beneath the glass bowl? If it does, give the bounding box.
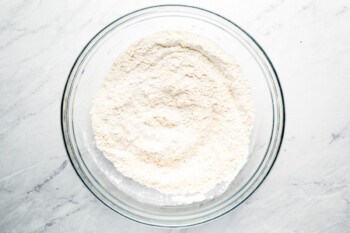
[0,0,350,233]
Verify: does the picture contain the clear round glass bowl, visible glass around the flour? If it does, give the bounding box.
[61,5,285,227]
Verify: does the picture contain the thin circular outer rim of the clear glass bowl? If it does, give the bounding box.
[60,4,286,227]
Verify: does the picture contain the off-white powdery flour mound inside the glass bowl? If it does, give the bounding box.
[91,31,254,194]
